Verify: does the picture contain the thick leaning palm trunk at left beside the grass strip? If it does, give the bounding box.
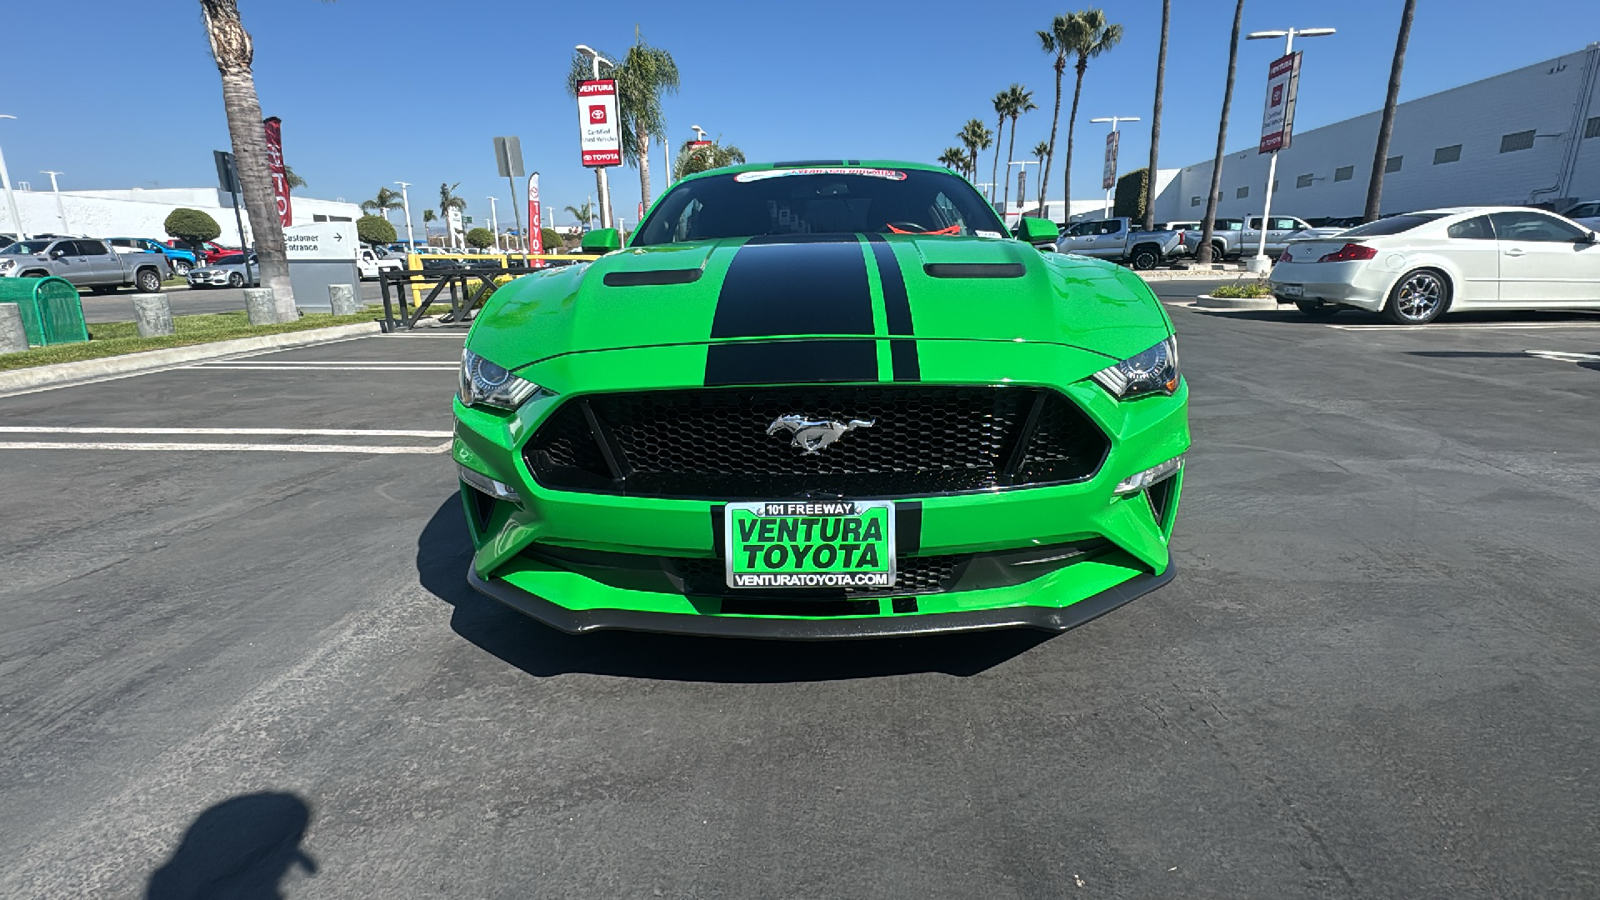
[200,0,299,322]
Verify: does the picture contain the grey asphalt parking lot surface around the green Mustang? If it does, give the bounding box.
[0,291,1600,898]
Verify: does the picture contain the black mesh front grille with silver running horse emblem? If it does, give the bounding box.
[525,384,1109,500]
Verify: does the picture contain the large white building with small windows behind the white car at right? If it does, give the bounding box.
[1155,43,1600,221]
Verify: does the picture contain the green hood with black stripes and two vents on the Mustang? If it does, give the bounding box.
[469,234,1170,368]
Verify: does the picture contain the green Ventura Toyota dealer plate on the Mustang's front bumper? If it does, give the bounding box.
[723,500,894,588]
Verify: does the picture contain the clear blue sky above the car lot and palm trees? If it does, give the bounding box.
[0,0,1600,226]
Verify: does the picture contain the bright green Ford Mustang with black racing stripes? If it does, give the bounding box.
[453,160,1189,637]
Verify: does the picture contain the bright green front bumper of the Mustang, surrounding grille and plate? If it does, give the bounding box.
[453,344,1189,639]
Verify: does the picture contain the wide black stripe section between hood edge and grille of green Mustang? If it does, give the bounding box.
[706,341,878,388]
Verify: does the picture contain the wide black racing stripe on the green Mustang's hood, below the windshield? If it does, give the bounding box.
[710,234,872,338]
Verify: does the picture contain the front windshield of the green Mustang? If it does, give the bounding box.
[630,167,1006,247]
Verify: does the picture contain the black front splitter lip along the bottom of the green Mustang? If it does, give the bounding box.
[467,562,1178,641]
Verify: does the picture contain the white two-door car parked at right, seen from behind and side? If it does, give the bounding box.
[1270,207,1600,325]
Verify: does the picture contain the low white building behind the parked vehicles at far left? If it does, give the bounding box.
[0,187,362,247]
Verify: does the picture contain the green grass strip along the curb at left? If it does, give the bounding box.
[0,307,382,372]
